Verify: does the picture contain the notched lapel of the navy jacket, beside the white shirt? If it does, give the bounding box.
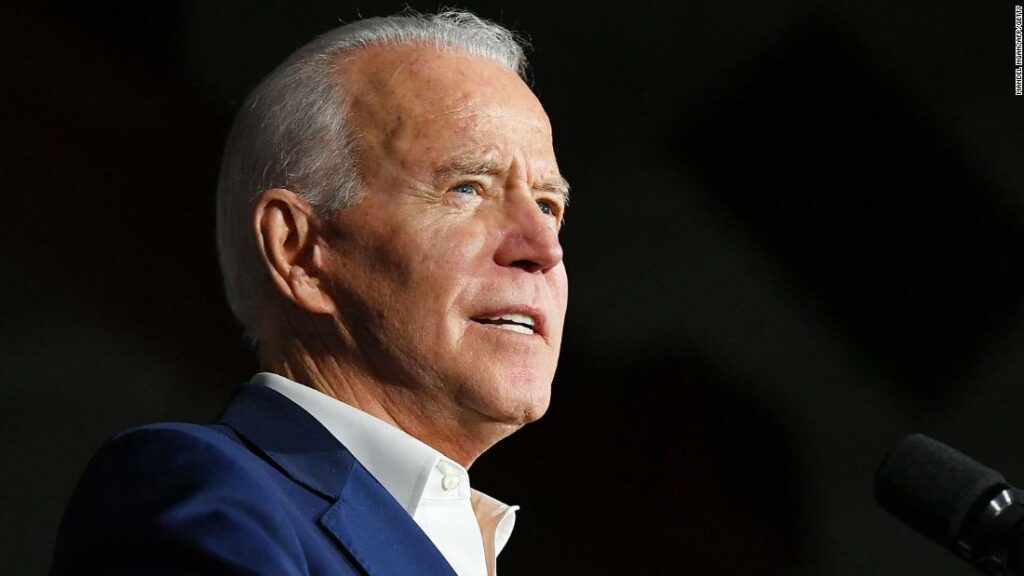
[221,385,455,576]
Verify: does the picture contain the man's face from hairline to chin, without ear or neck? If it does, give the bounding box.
[325,47,567,425]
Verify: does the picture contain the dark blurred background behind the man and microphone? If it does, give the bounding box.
[0,0,1024,576]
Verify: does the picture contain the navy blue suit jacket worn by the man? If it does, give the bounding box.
[52,385,455,576]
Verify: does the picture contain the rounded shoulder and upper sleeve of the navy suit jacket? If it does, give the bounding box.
[53,423,301,574]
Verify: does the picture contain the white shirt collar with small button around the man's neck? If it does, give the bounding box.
[252,372,491,518]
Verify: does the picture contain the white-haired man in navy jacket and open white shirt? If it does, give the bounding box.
[53,12,568,575]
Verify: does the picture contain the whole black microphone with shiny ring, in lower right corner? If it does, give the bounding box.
[874,434,1024,576]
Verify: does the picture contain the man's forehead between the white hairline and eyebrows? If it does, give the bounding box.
[343,45,553,171]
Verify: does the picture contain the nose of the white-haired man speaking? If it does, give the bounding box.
[495,195,563,274]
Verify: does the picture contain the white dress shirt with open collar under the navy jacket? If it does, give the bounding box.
[252,372,519,576]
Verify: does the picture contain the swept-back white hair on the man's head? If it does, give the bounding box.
[217,10,526,344]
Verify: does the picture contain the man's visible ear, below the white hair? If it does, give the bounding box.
[253,188,334,314]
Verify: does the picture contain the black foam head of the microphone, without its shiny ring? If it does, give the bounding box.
[874,434,1006,553]
